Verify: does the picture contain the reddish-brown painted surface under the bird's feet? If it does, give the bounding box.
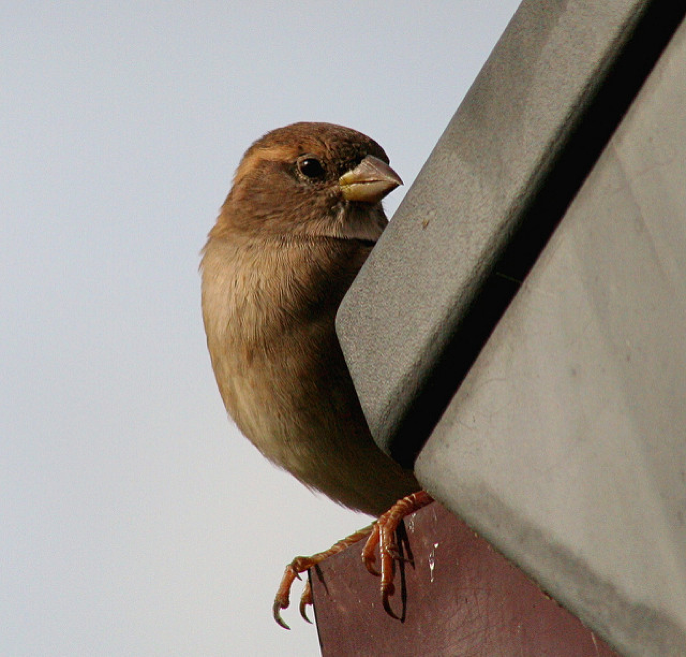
[311,503,618,657]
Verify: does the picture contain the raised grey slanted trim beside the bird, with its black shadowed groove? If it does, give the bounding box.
[337,0,684,465]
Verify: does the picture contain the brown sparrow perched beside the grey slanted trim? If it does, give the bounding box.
[201,123,430,627]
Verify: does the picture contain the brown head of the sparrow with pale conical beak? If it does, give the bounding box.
[218,123,402,242]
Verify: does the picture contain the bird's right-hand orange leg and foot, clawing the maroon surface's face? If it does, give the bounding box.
[362,490,433,618]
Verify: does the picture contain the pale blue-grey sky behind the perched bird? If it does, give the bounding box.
[0,0,518,657]
